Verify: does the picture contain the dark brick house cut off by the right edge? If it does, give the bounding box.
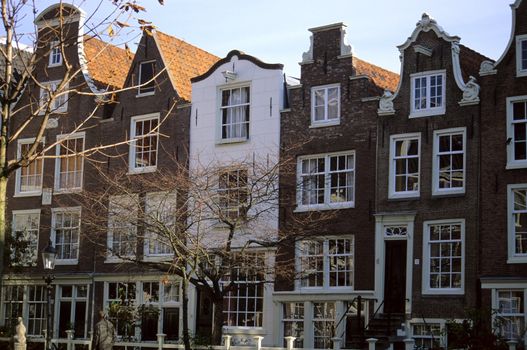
[479,0,527,347]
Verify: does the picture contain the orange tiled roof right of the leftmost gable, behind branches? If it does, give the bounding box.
[84,36,133,88]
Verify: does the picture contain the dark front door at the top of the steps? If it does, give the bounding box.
[384,240,406,313]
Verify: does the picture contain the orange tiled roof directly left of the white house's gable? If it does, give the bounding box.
[154,31,220,101]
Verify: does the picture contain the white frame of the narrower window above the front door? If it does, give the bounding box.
[388,132,421,199]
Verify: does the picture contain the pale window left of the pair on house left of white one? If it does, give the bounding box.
[108,195,139,258]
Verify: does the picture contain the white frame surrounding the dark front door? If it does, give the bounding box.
[375,213,415,315]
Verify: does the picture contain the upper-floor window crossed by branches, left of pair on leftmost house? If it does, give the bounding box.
[15,138,44,196]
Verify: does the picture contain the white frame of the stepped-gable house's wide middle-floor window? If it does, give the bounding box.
[295,150,357,212]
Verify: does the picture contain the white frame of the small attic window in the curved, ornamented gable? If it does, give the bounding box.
[409,69,446,118]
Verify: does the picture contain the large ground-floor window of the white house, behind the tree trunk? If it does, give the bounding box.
[222,253,266,327]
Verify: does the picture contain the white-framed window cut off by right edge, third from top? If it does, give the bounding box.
[507,184,527,263]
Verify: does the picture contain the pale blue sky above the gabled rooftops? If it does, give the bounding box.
[11,0,513,77]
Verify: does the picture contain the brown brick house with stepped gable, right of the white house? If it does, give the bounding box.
[273,23,398,348]
